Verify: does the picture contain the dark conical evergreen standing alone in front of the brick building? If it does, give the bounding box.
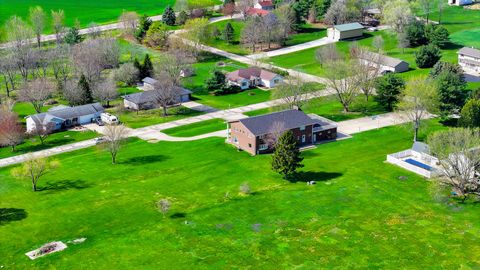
[272,130,303,179]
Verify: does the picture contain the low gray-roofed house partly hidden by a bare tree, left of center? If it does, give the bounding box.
[123,87,192,110]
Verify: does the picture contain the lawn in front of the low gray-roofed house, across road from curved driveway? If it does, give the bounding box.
[112,106,202,128]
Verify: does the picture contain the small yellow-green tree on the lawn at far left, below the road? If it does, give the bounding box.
[12,155,60,192]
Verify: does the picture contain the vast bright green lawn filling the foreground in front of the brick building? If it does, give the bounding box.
[4,122,480,269]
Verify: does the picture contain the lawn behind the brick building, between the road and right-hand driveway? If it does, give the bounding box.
[244,96,386,122]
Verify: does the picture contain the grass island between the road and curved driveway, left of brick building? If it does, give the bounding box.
[162,119,226,137]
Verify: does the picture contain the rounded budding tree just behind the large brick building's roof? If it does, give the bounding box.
[273,76,311,109]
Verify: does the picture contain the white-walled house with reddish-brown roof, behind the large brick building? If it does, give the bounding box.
[226,67,283,90]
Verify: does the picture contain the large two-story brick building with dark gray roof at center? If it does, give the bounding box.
[227,110,337,155]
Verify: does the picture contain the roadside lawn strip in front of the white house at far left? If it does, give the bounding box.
[0,131,98,159]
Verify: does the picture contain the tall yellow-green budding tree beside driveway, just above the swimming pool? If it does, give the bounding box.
[398,77,439,142]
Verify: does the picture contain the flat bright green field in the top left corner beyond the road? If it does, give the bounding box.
[0,0,176,32]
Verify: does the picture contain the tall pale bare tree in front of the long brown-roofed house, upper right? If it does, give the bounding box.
[352,48,385,101]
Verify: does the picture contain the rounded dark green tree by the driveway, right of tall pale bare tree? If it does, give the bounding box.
[375,73,405,111]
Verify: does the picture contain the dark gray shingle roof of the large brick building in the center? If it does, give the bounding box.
[234,110,322,136]
